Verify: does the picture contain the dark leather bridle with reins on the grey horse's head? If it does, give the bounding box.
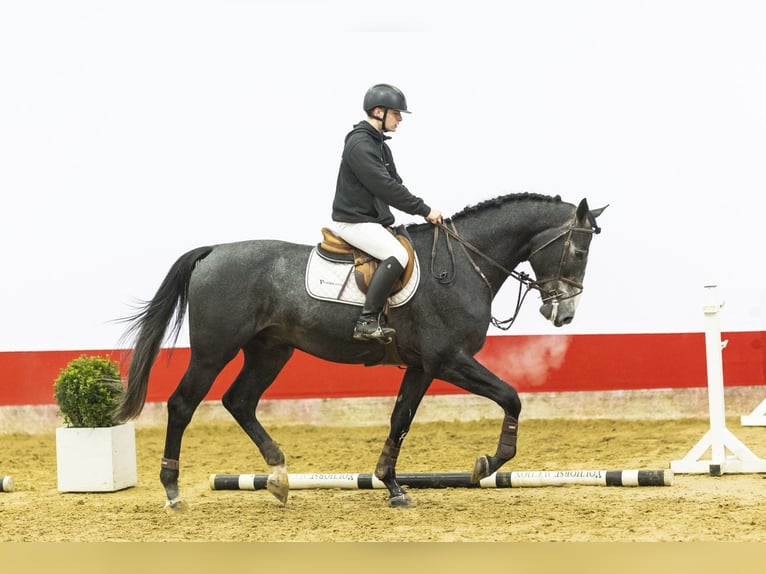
[431,213,601,331]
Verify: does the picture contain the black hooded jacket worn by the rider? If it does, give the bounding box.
[332,121,431,226]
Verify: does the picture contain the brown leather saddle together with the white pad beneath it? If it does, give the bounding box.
[306,228,420,307]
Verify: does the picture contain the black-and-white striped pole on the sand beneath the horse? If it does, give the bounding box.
[210,470,673,490]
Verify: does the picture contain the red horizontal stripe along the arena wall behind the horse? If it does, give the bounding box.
[0,331,766,405]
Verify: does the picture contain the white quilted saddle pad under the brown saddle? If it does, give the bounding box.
[306,247,420,307]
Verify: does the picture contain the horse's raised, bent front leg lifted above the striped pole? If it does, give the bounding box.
[439,353,521,483]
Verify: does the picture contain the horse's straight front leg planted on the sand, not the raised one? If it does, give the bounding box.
[375,368,433,508]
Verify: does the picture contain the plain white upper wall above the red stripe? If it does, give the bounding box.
[0,0,766,351]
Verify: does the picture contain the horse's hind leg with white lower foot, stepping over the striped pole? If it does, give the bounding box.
[222,341,293,504]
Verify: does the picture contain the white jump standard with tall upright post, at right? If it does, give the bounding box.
[670,285,766,476]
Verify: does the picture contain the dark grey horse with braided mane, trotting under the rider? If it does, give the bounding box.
[114,193,606,512]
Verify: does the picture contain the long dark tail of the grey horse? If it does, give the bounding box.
[114,247,213,422]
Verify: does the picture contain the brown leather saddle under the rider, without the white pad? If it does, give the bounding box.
[317,226,415,295]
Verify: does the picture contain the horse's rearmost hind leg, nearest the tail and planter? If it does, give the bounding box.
[160,360,225,511]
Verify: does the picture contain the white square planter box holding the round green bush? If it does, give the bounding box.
[56,422,137,492]
